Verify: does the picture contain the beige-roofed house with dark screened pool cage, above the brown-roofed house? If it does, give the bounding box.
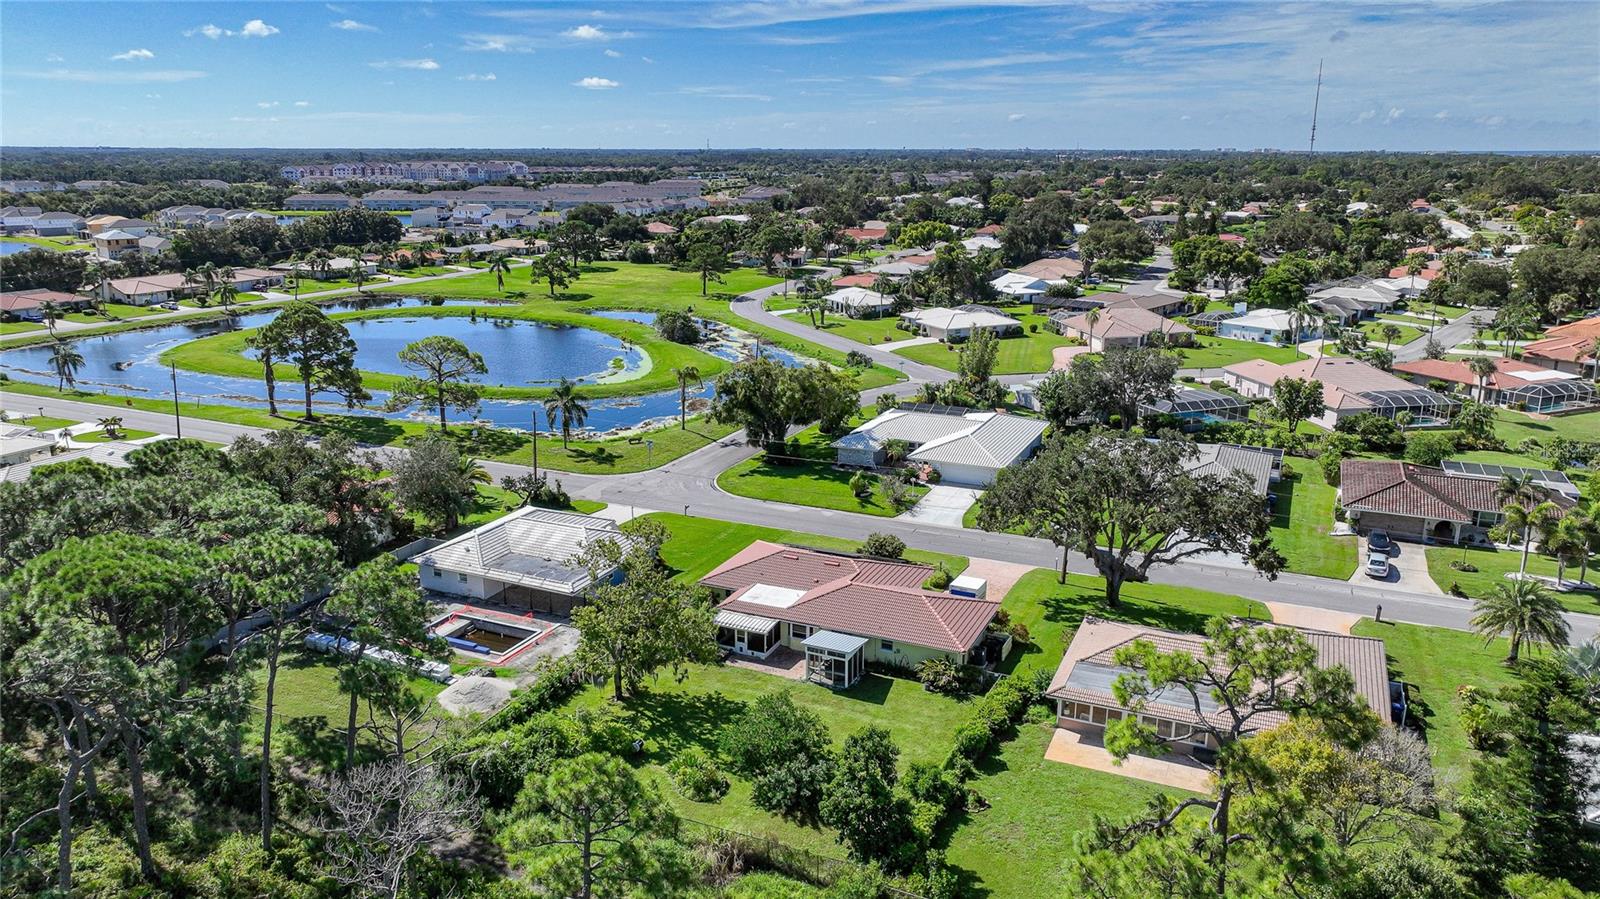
[1222,355,1461,430]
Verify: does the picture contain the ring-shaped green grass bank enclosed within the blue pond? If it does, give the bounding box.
[162,306,730,398]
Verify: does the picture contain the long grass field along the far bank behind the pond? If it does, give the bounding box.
[368,262,904,390]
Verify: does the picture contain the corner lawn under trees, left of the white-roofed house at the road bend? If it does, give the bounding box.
[717,416,928,517]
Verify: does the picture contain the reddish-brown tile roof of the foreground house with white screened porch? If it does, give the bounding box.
[701,541,1000,653]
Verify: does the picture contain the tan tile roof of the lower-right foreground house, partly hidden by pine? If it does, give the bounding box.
[1045,616,1389,729]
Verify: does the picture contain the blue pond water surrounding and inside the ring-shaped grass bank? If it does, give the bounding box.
[0,298,803,432]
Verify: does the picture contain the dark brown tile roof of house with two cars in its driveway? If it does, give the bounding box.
[1339,459,1573,523]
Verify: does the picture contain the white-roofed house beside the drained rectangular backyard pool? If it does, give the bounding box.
[414,505,632,614]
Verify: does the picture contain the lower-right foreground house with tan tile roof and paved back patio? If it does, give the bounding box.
[1045,616,1392,753]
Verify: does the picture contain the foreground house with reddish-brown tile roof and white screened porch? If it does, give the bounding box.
[701,541,1005,689]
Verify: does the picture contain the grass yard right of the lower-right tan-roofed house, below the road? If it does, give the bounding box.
[1352,619,1515,783]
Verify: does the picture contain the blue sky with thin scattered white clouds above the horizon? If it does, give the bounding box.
[0,0,1600,150]
